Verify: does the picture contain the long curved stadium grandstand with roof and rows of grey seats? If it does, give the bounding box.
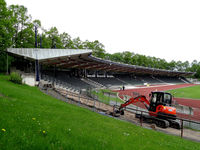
[7,48,193,92]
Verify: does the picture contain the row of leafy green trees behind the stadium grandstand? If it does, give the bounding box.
[0,0,200,78]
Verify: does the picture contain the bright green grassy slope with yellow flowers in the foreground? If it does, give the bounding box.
[0,75,200,150]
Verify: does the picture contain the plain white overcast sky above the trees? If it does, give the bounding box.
[6,0,200,62]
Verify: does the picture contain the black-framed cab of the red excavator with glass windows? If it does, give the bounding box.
[149,92,172,112]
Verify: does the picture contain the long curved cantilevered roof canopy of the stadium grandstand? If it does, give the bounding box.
[7,48,194,76]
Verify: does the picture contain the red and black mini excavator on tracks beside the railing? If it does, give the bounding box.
[114,91,180,129]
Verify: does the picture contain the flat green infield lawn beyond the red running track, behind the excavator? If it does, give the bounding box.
[168,85,200,100]
